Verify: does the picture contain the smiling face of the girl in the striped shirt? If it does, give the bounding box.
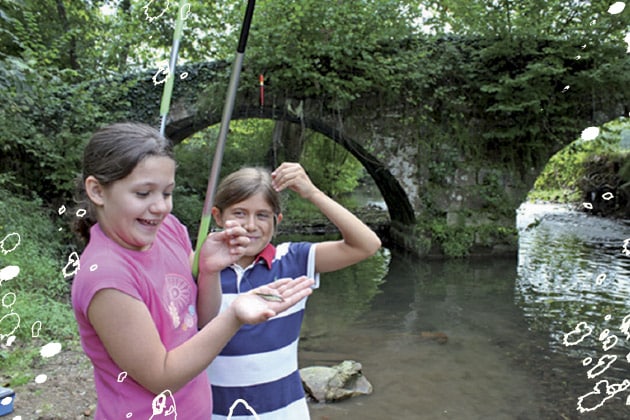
[212,192,282,267]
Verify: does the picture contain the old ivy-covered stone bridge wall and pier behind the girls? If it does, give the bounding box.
[118,62,628,255]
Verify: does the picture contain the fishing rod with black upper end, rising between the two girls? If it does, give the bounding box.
[192,0,256,277]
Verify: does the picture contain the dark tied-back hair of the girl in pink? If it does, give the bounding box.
[74,122,174,242]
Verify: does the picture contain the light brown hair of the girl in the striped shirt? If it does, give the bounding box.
[214,167,282,216]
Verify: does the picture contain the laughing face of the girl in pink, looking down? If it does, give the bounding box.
[85,156,175,251]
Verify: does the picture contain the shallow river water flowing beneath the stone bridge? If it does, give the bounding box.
[300,205,630,420]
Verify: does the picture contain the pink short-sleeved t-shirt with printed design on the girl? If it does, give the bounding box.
[72,215,212,420]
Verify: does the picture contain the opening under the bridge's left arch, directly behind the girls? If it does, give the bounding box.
[166,115,415,233]
